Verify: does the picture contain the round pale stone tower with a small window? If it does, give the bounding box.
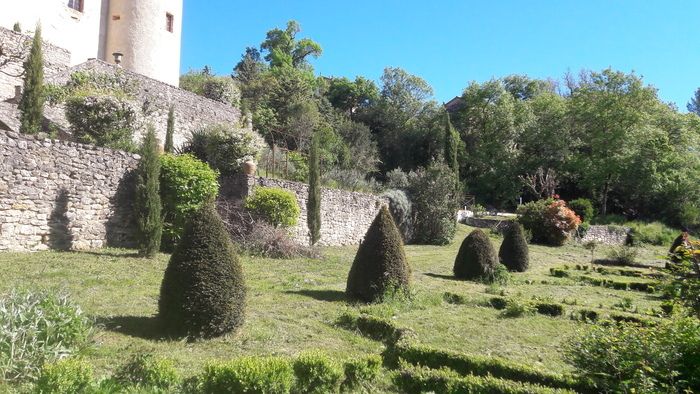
[104,0,183,86]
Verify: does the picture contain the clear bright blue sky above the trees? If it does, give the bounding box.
[181,0,700,111]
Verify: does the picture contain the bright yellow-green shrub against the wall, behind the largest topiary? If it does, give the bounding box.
[160,154,219,250]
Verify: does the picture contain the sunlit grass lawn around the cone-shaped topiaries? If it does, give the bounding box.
[0,225,665,386]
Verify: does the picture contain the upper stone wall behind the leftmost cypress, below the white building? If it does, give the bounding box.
[0,27,70,101]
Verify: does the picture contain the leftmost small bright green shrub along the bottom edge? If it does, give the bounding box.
[35,358,93,394]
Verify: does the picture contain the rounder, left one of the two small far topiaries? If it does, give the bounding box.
[453,229,498,279]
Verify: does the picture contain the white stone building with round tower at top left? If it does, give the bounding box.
[0,0,183,86]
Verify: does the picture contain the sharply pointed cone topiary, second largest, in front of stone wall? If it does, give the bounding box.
[346,206,411,302]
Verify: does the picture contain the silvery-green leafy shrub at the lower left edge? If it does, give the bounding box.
[0,291,92,381]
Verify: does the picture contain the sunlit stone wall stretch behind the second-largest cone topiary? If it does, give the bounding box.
[221,176,386,246]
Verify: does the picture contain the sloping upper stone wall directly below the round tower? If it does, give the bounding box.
[46,59,246,147]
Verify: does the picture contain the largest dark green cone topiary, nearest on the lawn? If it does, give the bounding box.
[158,203,245,337]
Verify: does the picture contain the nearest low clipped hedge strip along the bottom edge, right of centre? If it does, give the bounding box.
[393,365,574,394]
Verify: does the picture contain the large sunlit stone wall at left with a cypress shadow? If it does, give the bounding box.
[0,131,138,251]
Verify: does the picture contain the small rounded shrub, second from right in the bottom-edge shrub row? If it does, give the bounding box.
[293,352,343,394]
